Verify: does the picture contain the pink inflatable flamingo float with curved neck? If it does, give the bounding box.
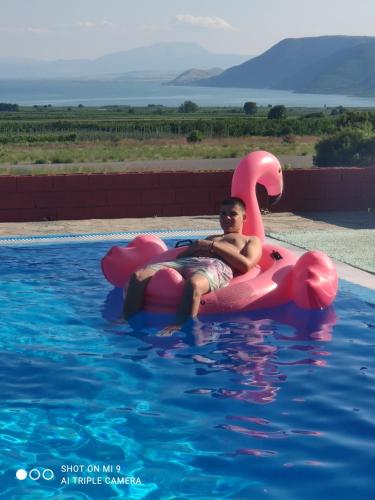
[102,151,338,315]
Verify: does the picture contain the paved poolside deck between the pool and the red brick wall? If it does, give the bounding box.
[0,212,375,290]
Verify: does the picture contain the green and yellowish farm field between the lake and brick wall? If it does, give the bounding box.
[0,105,356,173]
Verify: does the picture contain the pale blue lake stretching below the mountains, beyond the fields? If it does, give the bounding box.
[0,80,375,108]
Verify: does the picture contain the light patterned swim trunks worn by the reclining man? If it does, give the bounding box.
[147,257,233,292]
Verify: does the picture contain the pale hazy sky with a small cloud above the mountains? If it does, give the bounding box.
[0,0,375,60]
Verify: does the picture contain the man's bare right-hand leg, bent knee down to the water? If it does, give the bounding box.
[177,273,210,324]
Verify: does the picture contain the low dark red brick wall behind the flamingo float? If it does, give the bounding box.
[0,167,375,222]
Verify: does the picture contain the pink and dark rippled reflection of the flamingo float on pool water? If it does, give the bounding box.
[103,289,337,406]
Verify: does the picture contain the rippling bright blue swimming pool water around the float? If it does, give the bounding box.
[0,242,375,500]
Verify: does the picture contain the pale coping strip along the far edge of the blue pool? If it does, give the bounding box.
[0,227,375,291]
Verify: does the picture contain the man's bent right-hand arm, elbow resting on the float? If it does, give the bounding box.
[211,236,262,274]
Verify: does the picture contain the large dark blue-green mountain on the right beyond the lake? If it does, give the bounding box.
[196,36,375,95]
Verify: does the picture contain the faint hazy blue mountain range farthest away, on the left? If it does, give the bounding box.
[0,42,253,79]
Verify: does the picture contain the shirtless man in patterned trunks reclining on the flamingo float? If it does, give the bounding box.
[124,198,262,325]
